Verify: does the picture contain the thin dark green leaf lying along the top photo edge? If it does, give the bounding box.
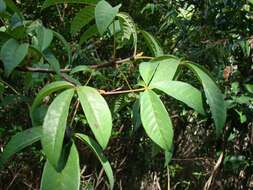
[42,0,99,9]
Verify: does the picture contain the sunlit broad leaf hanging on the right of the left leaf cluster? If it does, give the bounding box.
[77,86,112,149]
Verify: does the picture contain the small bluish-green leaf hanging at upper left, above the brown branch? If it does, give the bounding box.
[36,26,53,52]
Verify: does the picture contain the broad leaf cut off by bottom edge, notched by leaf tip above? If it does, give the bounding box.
[40,143,80,190]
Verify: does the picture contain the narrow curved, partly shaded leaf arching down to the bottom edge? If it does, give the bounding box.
[76,133,114,189]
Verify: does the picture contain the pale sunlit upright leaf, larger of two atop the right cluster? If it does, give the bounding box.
[150,56,180,84]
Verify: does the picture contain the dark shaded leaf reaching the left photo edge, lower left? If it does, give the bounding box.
[0,127,42,168]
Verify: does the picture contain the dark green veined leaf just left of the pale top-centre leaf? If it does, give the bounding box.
[70,7,95,34]
